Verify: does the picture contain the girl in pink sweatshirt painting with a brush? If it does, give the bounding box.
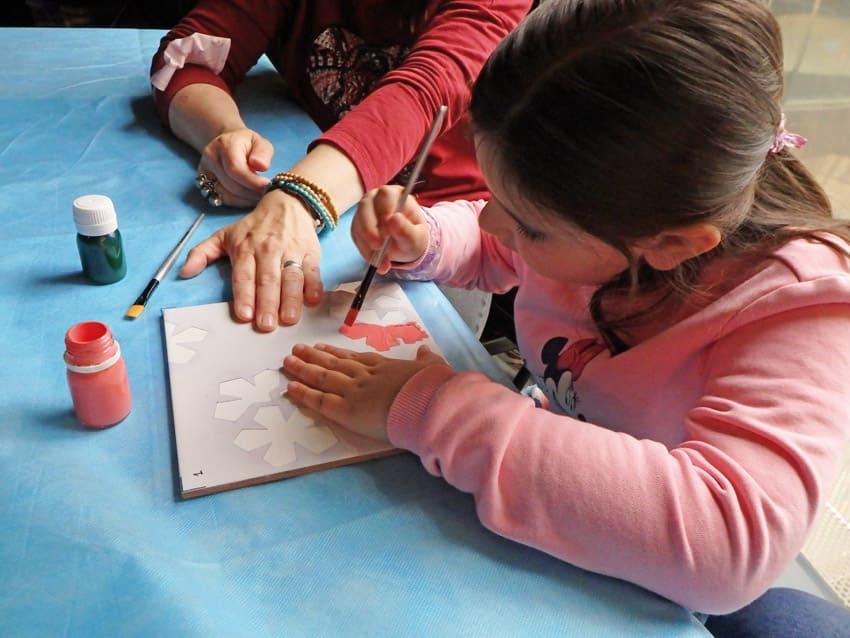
[284,0,850,614]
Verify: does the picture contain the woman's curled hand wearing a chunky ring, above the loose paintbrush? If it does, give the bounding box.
[198,127,274,208]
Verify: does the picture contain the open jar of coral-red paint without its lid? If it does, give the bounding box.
[65,321,132,428]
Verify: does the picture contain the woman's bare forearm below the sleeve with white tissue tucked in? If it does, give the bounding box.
[168,84,245,153]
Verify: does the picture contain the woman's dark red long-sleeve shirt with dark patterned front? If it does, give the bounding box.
[151,0,531,204]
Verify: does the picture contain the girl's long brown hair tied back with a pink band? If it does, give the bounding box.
[471,0,850,353]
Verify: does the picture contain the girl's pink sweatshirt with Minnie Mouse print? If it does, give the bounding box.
[388,202,850,614]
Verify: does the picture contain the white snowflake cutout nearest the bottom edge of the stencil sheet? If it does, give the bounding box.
[233,405,338,467]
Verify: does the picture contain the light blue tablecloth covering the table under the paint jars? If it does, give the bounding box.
[0,29,705,637]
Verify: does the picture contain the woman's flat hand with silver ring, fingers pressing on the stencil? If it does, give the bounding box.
[180,190,322,332]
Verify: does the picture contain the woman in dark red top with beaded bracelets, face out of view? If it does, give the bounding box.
[151,0,531,331]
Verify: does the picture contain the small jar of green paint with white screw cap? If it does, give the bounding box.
[74,195,127,284]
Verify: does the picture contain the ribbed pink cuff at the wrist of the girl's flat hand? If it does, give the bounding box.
[387,365,456,454]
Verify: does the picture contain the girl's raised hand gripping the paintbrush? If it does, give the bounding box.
[351,186,428,275]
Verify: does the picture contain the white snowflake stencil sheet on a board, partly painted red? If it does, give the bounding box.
[163,280,439,498]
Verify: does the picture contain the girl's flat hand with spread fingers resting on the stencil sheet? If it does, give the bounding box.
[283,344,446,441]
